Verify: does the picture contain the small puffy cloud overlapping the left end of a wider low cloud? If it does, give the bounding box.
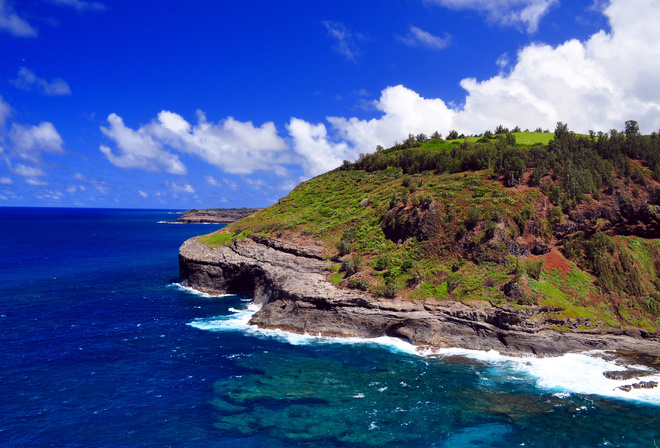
[99,114,186,174]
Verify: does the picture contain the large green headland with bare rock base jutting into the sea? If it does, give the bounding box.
[179,121,660,357]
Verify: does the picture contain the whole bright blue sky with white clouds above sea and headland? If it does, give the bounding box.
[0,0,660,210]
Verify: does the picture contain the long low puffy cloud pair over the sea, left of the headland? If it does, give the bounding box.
[101,111,289,174]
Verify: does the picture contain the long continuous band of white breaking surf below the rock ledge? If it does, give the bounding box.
[188,303,660,405]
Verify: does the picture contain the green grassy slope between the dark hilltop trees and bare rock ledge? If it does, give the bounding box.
[200,133,660,331]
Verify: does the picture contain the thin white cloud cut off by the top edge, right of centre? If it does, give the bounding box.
[425,0,558,33]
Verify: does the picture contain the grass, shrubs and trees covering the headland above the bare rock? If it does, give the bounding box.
[200,121,660,331]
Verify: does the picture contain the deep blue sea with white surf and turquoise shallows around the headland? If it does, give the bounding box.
[0,208,660,448]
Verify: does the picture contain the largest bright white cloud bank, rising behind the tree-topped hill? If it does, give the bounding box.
[314,0,660,158]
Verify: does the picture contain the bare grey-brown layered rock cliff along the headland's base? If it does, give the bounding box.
[179,234,660,356]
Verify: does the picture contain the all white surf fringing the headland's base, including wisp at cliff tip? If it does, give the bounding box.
[179,284,660,405]
